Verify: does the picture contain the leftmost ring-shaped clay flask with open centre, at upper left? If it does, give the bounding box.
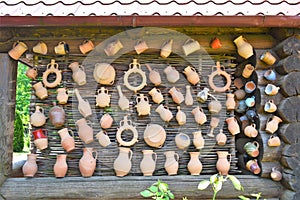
[43,59,62,88]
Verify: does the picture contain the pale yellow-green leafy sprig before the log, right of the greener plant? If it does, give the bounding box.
[198,174,244,200]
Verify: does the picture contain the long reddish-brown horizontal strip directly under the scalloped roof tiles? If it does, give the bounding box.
[0,16,300,28]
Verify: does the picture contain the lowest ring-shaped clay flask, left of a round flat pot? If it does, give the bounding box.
[116,116,138,147]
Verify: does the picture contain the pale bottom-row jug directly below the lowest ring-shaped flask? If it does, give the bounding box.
[114,147,133,177]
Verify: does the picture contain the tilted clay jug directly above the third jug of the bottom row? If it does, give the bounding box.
[76,118,94,144]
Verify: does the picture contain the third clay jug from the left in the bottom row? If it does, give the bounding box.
[79,148,98,177]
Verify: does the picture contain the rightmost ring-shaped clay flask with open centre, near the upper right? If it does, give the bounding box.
[208,62,231,92]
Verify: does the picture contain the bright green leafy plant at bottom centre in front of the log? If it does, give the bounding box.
[140,180,175,200]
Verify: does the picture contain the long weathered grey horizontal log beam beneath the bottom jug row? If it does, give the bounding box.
[0,175,282,199]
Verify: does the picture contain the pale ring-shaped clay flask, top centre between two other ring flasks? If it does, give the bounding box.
[124,59,147,93]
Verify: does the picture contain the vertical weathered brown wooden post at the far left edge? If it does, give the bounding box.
[0,54,17,185]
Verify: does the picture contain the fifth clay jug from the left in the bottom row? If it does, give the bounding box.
[140,150,157,176]
